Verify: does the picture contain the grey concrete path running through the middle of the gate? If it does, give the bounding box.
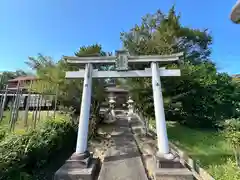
[98,114,148,180]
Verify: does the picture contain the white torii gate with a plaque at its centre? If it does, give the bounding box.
[64,51,183,159]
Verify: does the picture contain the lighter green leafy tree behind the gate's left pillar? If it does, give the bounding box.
[26,44,107,118]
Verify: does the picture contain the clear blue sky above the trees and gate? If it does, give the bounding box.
[0,0,240,74]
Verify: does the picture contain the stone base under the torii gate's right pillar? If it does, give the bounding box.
[155,153,194,180]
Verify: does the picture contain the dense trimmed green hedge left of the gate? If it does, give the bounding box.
[0,116,77,180]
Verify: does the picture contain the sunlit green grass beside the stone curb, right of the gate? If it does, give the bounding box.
[168,123,240,180]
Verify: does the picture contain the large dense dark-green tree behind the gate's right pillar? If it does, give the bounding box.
[121,6,240,128]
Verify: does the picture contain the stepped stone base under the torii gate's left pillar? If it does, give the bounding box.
[54,152,100,180]
